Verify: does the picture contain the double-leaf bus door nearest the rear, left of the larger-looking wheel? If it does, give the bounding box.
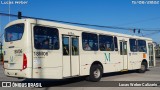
[62,35,79,77]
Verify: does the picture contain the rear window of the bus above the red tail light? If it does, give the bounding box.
[5,23,24,42]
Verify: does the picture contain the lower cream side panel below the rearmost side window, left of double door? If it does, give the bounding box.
[33,50,62,79]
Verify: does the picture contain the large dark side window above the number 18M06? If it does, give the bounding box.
[34,26,59,50]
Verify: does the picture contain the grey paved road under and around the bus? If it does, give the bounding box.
[0,59,160,90]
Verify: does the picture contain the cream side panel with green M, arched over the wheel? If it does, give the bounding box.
[81,51,123,75]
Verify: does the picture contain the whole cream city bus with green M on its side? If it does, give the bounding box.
[4,19,155,81]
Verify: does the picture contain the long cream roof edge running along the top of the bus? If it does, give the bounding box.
[5,18,152,41]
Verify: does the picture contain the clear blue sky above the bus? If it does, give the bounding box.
[0,0,160,43]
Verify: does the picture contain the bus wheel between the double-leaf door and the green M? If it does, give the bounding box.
[86,65,103,82]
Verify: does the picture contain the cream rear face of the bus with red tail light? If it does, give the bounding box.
[4,23,31,77]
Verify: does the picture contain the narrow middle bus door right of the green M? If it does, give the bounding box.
[120,41,128,70]
